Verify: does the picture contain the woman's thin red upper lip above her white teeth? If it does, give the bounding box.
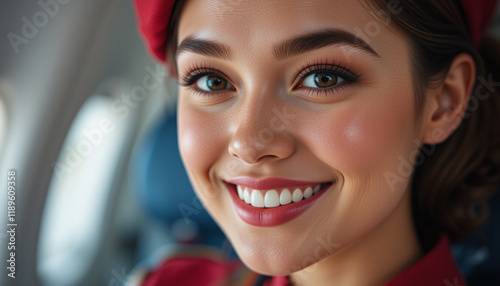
[226,176,330,190]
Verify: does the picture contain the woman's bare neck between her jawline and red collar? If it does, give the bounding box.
[290,191,423,286]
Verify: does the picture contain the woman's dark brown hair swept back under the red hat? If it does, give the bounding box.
[167,0,500,248]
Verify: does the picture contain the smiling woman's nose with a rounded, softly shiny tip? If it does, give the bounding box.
[228,104,295,165]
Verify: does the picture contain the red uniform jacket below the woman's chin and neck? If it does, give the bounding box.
[134,236,465,286]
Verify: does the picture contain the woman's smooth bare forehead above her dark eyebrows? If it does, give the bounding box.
[178,0,402,59]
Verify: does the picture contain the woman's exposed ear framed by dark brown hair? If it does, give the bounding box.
[422,53,476,144]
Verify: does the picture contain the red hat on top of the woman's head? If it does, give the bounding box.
[134,0,497,63]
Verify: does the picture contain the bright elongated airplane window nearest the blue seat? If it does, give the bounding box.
[37,90,139,286]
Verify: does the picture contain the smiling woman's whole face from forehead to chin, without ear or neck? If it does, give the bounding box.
[177,0,422,275]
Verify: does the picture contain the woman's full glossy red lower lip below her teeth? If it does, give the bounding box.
[226,183,332,227]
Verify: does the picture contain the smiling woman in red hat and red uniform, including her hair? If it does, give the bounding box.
[131,0,500,286]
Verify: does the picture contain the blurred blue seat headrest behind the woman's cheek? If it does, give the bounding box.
[131,110,222,245]
